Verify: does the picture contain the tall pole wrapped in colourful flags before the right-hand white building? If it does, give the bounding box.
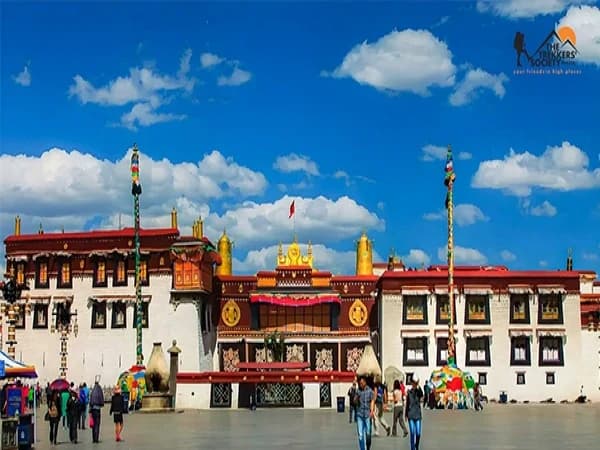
[444,146,456,366]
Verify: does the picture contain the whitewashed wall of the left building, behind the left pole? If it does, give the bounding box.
[10,274,203,385]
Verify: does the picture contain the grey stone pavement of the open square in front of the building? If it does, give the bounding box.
[29,404,600,450]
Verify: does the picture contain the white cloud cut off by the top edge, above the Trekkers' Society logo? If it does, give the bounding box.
[477,0,595,19]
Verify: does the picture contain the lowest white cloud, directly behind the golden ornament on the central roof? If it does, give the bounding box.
[233,242,381,275]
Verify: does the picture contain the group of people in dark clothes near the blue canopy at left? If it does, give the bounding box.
[45,380,125,445]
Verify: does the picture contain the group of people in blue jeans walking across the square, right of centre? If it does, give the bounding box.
[348,376,424,450]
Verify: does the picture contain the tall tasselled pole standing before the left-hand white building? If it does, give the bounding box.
[131,144,144,366]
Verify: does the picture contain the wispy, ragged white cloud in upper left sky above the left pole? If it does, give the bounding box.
[69,49,196,130]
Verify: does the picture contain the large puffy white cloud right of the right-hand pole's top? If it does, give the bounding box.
[471,141,600,197]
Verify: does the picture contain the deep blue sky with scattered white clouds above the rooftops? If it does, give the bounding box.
[0,0,600,272]
